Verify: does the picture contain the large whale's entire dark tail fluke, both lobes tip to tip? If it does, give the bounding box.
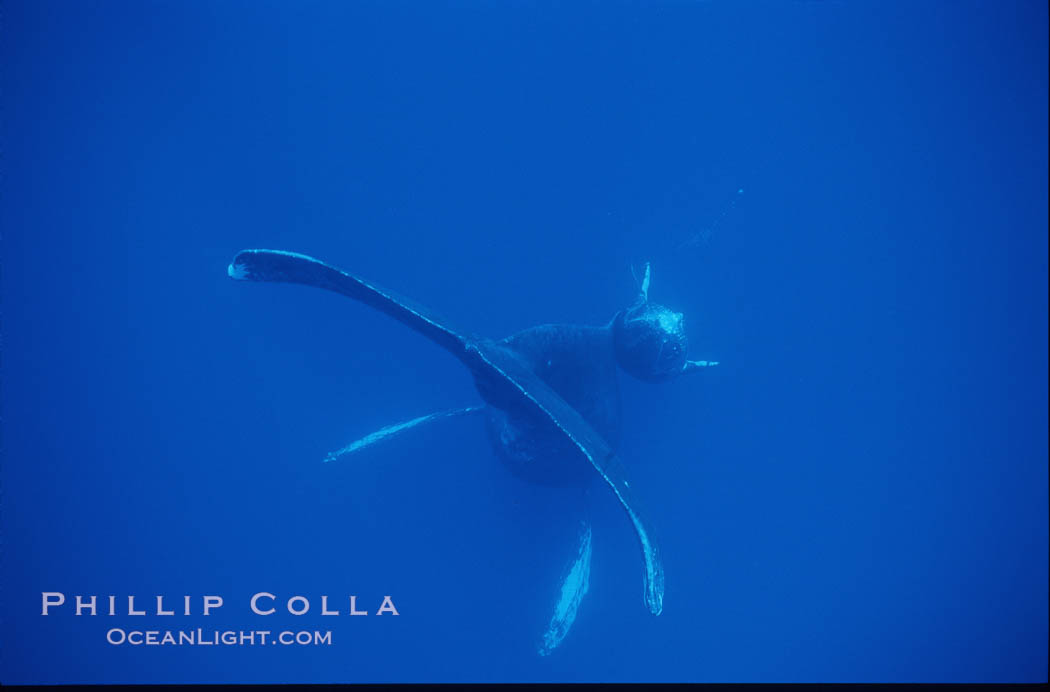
[227,250,664,615]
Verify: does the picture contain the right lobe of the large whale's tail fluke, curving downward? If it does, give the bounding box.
[467,341,664,615]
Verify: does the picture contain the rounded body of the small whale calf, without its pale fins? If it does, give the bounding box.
[613,302,689,382]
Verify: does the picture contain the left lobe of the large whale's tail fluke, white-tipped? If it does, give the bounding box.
[233,250,469,365]
